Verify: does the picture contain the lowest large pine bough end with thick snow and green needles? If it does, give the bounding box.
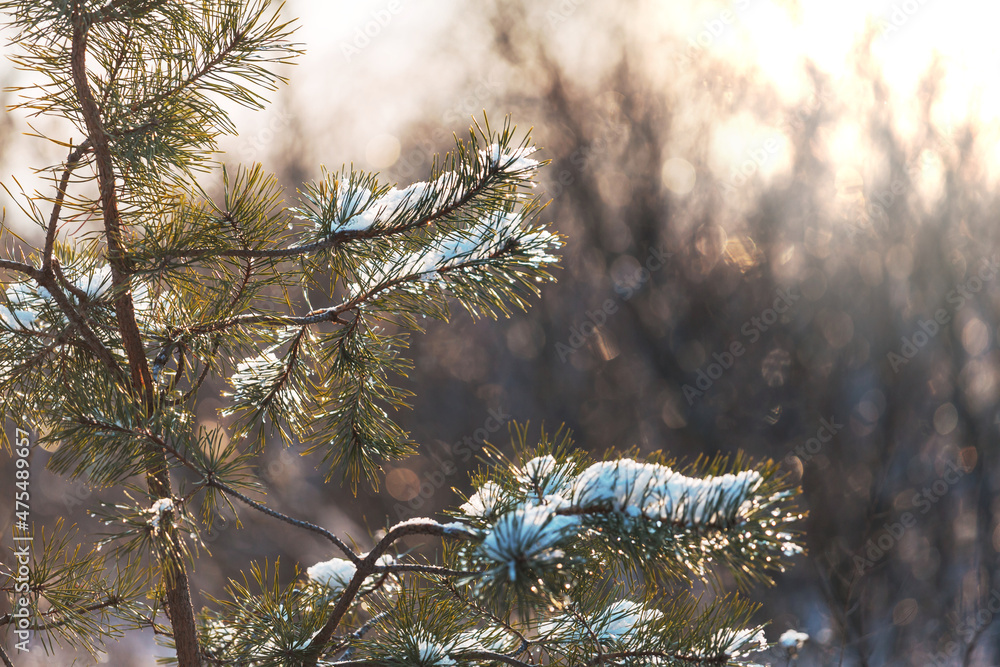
[456,454,801,595]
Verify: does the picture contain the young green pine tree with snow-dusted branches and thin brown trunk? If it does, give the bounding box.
[0,0,801,667]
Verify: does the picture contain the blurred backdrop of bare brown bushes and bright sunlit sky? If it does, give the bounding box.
[0,0,1000,666]
